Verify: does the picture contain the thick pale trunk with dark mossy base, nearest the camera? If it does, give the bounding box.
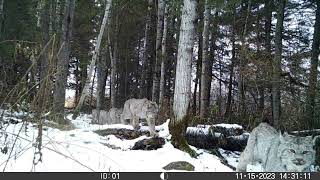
[169,0,197,155]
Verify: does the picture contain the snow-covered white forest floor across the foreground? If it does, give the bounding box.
[0,109,240,172]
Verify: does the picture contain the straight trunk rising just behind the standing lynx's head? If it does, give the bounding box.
[152,0,165,103]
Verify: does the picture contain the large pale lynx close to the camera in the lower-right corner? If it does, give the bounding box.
[237,123,316,172]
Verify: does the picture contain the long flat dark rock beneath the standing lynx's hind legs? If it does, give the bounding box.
[94,129,149,139]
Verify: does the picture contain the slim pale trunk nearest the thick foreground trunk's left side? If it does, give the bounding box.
[159,5,168,109]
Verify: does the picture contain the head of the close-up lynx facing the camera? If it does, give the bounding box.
[277,133,315,172]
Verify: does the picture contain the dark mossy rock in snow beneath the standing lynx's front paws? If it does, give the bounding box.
[131,137,165,150]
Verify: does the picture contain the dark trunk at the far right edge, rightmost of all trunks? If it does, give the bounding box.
[306,1,320,128]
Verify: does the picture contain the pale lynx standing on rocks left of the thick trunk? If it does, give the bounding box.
[121,98,158,136]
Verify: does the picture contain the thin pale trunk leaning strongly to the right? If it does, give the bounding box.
[73,0,112,118]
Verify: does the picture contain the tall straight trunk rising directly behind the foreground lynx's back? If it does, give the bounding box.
[272,0,286,128]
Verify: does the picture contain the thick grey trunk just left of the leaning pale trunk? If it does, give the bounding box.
[53,0,75,124]
